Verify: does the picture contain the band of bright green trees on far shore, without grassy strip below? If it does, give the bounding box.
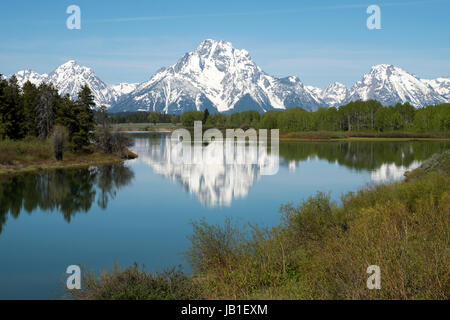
[111,100,450,132]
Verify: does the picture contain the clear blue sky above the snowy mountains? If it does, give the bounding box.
[0,0,450,87]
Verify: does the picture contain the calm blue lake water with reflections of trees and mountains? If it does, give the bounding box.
[0,133,449,299]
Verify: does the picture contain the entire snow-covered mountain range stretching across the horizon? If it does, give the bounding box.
[5,39,450,114]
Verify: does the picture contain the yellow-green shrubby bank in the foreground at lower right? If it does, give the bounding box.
[69,151,450,299]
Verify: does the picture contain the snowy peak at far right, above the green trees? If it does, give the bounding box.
[346,64,445,107]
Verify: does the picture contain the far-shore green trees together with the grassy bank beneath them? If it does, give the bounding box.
[111,100,450,139]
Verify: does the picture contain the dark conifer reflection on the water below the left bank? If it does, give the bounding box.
[0,164,134,233]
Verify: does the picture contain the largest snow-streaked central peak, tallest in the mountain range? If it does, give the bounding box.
[111,39,322,113]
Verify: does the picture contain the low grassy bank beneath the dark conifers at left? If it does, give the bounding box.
[0,138,136,175]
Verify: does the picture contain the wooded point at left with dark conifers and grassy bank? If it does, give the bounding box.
[0,76,136,174]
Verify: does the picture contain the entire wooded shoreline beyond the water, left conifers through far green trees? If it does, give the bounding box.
[0,76,450,174]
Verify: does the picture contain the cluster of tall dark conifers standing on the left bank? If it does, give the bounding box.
[0,75,95,151]
